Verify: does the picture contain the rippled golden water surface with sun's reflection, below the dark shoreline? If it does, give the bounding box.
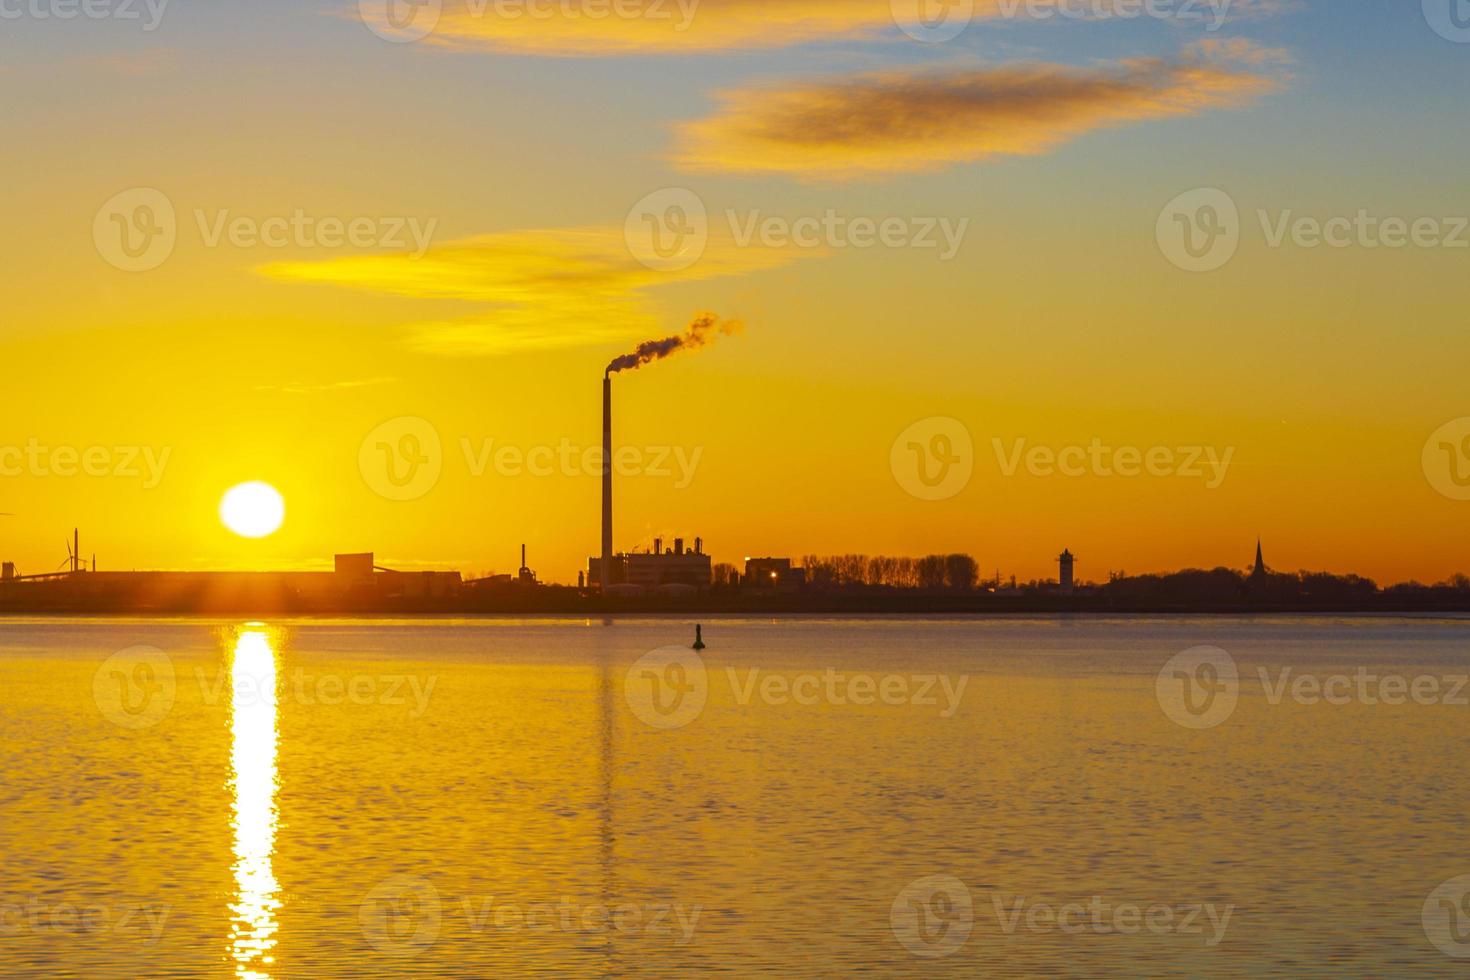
[0,619,1470,979]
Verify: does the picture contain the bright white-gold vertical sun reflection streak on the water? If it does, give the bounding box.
[229,623,281,980]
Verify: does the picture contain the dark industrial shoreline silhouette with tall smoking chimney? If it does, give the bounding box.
[0,314,1470,614]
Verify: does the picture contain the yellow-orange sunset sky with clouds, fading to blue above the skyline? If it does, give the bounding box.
[0,0,1470,582]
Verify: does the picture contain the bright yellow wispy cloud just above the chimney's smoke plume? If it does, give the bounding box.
[260,228,800,356]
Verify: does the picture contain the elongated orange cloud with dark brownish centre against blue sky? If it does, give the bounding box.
[673,40,1288,179]
